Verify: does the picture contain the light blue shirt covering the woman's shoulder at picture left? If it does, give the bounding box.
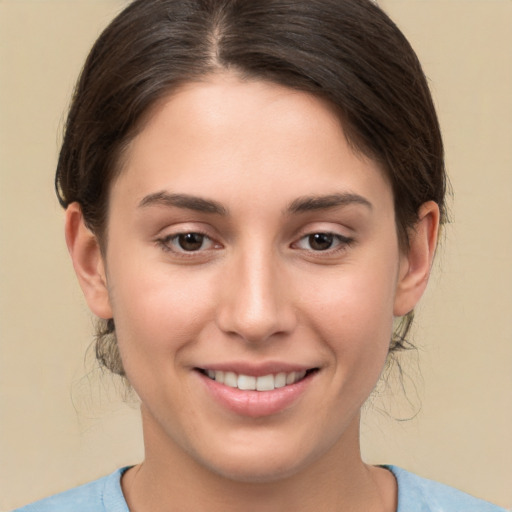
[13,468,129,512]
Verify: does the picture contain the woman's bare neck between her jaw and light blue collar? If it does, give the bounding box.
[122,406,396,512]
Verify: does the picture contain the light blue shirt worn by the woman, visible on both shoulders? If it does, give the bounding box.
[14,466,506,512]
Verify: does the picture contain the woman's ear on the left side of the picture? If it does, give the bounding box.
[66,203,112,319]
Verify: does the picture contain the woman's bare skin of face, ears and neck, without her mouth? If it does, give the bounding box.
[66,74,439,512]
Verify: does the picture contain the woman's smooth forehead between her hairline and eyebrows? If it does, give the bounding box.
[113,74,389,213]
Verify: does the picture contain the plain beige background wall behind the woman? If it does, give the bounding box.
[0,0,512,511]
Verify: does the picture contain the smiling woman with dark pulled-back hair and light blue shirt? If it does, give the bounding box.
[14,0,506,512]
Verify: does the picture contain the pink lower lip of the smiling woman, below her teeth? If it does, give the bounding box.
[198,372,316,418]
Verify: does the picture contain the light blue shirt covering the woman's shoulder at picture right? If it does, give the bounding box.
[385,466,506,512]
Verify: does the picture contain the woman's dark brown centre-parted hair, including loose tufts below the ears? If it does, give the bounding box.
[55,0,446,375]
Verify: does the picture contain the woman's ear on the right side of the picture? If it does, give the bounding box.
[394,201,439,316]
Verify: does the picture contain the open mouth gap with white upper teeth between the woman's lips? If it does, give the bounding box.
[197,368,318,391]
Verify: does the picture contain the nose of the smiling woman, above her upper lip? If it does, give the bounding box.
[217,248,297,343]
